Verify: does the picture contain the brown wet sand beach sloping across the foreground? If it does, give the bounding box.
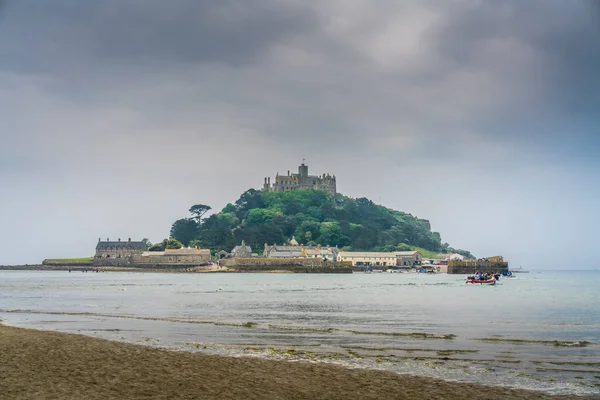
[0,324,600,399]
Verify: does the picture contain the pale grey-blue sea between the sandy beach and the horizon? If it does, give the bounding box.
[0,271,600,395]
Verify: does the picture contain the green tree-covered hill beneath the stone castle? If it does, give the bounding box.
[170,189,472,257]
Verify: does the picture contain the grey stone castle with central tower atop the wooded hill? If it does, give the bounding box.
[263,162,337,196]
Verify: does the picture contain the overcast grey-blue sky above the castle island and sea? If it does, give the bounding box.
[0,0,600,269]
